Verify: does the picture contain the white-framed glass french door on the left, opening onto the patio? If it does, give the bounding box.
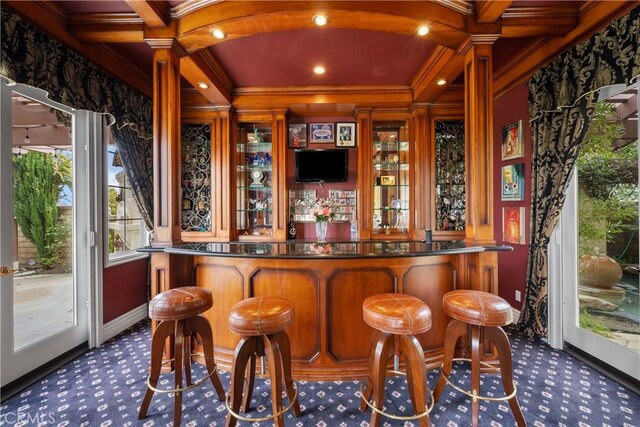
[0,78,101,387]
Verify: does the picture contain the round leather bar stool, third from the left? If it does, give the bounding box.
[360,294,433,427]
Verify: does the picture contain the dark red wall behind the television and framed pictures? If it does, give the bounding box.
[287,117,360,240]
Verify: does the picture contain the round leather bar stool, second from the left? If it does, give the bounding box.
[225,296,302,427]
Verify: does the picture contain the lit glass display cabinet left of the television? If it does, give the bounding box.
[235,122,273,239]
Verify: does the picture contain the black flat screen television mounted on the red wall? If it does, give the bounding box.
[295,148,349,182]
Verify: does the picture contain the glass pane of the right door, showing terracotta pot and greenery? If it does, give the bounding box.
[578,96,640,353]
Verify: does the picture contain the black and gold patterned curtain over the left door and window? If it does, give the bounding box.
[0,9,153,230]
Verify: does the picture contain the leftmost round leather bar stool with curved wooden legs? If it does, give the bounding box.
[138,286,224,426]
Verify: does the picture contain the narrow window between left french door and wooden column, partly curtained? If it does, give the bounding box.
[106,143,147,261]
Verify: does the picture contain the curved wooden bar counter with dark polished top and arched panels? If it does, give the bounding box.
[147,241,509,380]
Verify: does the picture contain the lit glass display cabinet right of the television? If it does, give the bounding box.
[371,121,410,237]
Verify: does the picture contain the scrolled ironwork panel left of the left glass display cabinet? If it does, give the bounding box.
[180,124,211,231]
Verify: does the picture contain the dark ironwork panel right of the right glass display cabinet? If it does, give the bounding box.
[435,120,466,230]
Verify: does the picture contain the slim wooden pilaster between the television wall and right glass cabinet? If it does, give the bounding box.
[356,108,373,240]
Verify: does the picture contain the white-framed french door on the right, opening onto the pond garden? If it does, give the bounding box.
[549,86,640,380]
